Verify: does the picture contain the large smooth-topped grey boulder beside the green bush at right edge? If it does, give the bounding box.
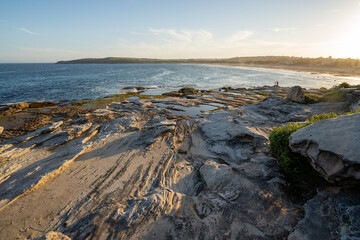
[289,113,360,182]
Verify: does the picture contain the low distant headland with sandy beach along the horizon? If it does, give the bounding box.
[57,56,360,76]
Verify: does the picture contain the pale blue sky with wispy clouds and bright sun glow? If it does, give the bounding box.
[0,0,360,63]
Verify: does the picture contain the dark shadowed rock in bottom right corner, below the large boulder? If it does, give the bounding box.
[288,188,360,240]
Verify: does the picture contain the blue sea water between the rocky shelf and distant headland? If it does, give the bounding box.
[0,64,360,104]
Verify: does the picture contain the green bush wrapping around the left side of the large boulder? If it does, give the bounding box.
[269,110,359,194]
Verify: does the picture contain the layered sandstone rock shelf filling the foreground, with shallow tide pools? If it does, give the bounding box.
[0,86,360,239]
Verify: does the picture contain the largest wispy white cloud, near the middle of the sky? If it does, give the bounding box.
[149,28,213,45]
